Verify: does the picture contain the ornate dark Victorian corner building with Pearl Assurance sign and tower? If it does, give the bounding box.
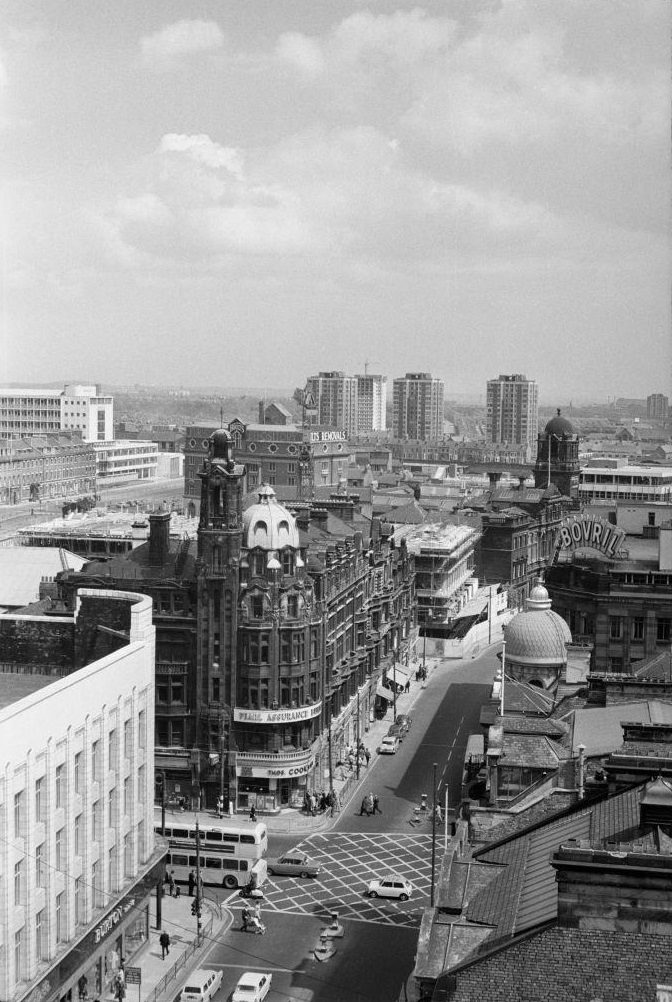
[60,429,415,812]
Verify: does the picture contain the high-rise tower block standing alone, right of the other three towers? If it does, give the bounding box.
[487,373,539,460]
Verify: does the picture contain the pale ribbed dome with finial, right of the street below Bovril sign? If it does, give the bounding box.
[504,581,572,666]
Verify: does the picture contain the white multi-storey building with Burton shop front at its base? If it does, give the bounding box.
[0,589,165,1002]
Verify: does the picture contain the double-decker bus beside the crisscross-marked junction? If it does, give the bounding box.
[154,808,268,890]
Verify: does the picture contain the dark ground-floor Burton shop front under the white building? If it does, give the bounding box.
[20,849,166,1002]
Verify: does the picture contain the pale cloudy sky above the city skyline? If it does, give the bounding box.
[0,0,672,404]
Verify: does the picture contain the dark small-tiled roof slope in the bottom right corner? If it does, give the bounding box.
[449,926,672,1002]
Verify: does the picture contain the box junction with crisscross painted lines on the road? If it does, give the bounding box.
[228,832,434,928]
